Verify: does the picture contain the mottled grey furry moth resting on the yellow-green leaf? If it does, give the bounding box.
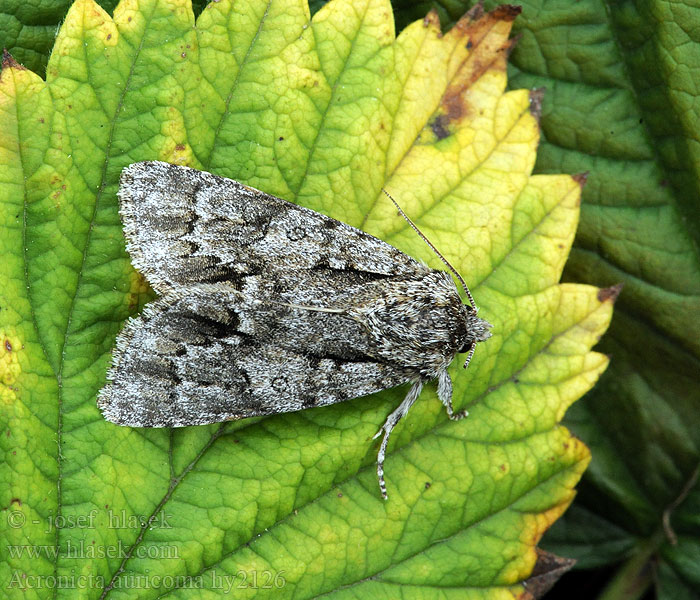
[98,162,491,499]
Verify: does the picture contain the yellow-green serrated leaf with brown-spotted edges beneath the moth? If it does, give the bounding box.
[0,0,615,598]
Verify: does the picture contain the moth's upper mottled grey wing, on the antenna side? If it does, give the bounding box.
[119,162,425,293]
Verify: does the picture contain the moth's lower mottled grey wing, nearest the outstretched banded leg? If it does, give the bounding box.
[98,284,411,427]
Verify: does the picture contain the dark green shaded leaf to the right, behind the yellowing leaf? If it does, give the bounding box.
[486,0,700,599]
